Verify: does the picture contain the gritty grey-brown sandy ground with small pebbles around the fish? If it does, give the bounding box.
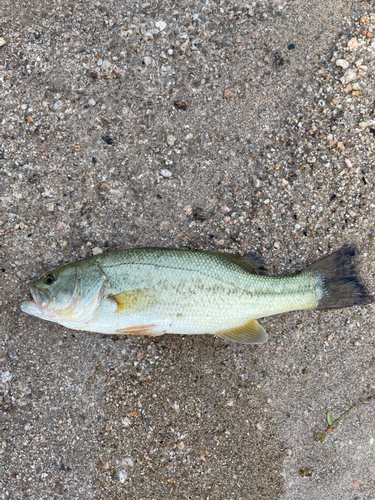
[0,0,375,500]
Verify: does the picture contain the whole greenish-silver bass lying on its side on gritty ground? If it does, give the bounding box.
[20,246,373,344]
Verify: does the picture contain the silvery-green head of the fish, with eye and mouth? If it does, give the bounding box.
[21,263,107,328]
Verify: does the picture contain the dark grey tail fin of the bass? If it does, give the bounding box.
[303,246,374,310]
